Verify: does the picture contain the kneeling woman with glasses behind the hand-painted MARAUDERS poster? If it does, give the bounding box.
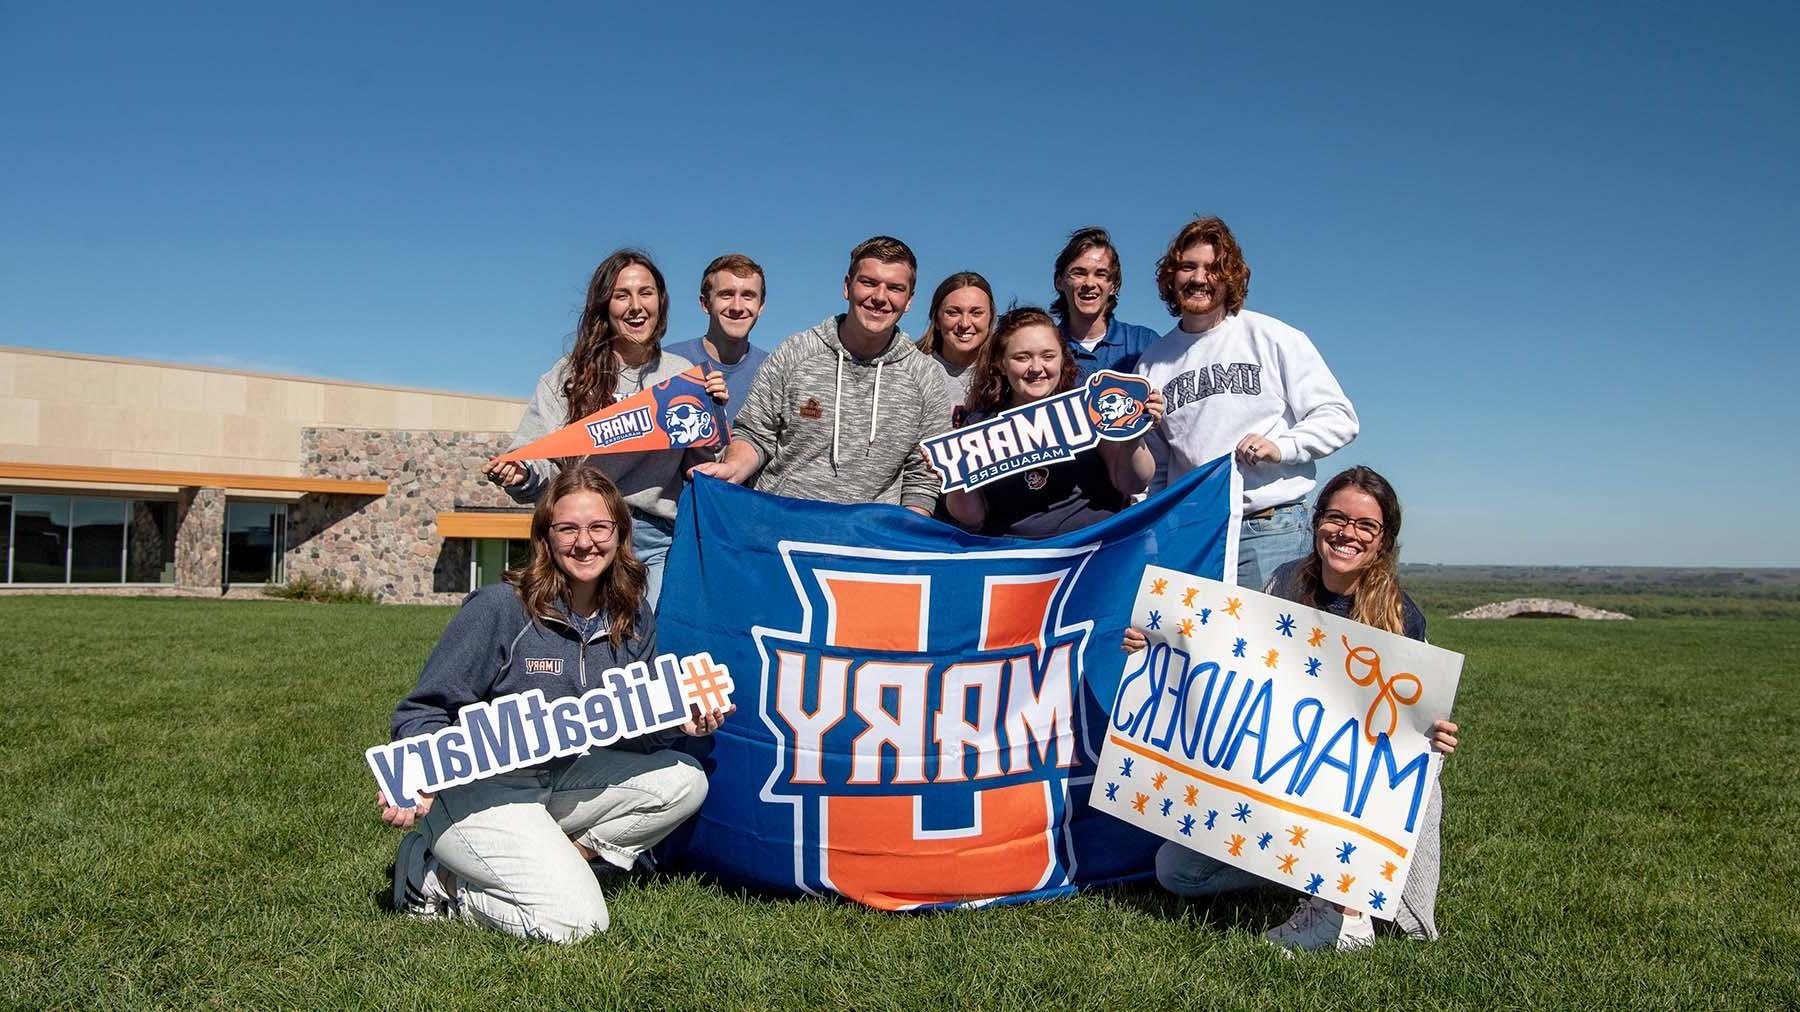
[1125,466,1458,949]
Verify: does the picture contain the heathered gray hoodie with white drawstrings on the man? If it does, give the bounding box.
[734,315,950,513]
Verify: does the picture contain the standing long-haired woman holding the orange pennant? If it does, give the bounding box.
[484,248,729,607]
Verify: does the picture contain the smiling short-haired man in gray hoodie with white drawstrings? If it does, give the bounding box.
[693,236,950,517]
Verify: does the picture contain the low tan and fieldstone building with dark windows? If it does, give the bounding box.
[0,348,527,603]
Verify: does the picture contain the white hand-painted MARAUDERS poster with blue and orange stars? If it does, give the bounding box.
[1093,565,1462,920]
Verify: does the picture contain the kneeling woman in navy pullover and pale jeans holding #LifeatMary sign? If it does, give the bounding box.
[376,466,725,942]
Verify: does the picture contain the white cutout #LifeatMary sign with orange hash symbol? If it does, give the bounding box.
[364,654,733,809]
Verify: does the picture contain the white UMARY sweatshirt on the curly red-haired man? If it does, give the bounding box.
[1138,310,1357,513]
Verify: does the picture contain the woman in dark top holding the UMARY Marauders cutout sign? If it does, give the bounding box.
[945,306,1163,538]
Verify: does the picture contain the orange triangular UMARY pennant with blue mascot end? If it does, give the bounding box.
[497,366,731,461]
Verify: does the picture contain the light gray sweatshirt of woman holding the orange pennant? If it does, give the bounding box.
[506,351,711,522]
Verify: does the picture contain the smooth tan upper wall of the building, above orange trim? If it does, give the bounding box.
[0,348,524,475]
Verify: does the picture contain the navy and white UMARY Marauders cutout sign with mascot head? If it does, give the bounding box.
[920,369,1150,492]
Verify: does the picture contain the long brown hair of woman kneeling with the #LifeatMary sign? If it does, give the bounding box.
[506,465,648,648]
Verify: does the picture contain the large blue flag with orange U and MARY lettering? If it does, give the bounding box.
[659,457,1240,909]
